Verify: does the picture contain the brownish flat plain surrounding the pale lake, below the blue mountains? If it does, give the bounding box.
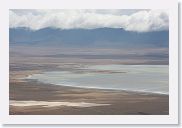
[9,46,169,115]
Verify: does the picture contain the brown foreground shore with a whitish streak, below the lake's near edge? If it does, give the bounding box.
[10,81,169,115]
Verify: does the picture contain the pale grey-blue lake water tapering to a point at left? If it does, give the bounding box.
[28,65,169,94]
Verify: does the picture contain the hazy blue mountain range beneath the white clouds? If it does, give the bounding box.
[9,28,169,48]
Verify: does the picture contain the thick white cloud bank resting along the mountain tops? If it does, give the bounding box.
[9,9,169,32]
